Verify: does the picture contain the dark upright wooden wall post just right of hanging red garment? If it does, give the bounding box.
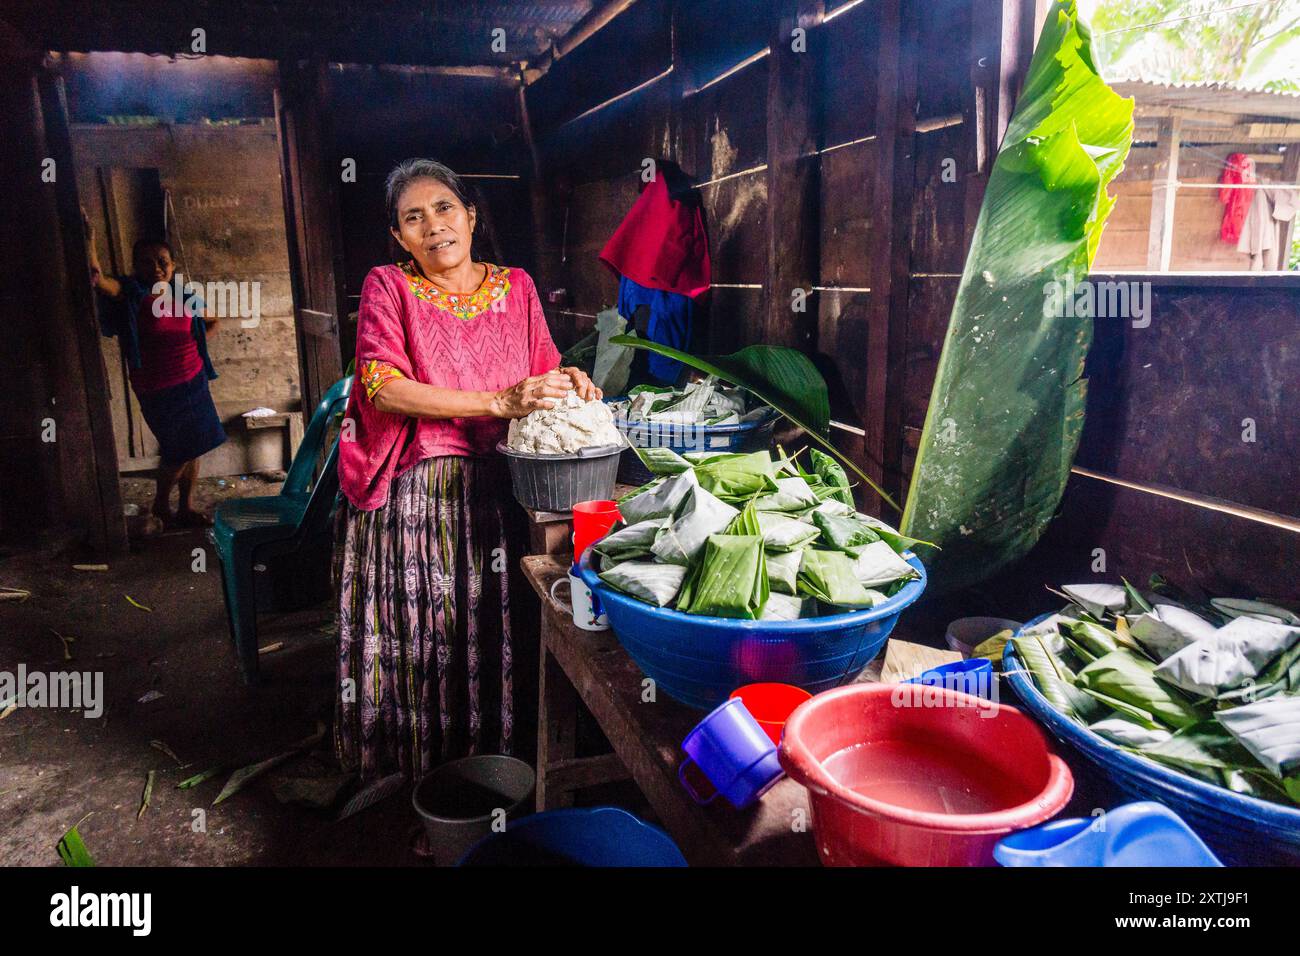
[745,0,823,350]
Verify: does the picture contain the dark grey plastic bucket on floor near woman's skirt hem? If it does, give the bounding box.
[411,754,537,866]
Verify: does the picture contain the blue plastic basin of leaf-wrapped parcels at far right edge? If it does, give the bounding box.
[1002,614,1300,866]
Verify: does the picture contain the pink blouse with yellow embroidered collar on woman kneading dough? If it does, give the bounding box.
[338,264,560,511]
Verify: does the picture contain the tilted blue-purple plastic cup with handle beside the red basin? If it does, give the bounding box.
[677,697,781,810]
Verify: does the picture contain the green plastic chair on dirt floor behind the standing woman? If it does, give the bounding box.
[208,376,352,684]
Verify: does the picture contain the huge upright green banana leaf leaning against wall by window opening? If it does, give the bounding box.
[901,0,1134,588]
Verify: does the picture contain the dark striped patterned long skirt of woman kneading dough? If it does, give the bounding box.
[334,457,527,779]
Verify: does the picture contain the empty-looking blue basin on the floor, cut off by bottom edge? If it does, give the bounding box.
[459,806,686,866]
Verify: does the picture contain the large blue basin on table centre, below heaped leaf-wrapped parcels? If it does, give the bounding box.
[579,549,926,710]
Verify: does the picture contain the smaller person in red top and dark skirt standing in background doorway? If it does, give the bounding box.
[86,231,226,528]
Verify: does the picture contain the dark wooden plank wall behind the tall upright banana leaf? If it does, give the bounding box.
[527,0,1300,614]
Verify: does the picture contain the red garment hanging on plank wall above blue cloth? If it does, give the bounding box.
[601,176,711,298]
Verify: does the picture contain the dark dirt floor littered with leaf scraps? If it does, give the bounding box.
[0,477,424,865]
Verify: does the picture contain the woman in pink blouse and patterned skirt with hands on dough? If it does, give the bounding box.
[335,160,601,778]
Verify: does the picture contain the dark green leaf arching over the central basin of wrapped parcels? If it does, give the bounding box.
[610,336,900,511]
